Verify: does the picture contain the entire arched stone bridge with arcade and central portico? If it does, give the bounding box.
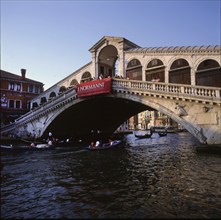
[1,36,221,144]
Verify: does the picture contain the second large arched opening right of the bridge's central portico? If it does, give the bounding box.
[146,59,165,82]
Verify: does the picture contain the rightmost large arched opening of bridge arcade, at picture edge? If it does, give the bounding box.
[196,59,221,87]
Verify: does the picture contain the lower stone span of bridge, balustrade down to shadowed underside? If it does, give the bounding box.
[1,78,221,145]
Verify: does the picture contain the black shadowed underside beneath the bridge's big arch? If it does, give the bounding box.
[45,95,151,140]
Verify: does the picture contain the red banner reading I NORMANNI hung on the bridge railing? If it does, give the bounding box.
[77,78,111,97]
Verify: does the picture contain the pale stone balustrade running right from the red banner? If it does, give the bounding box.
[112,79,221,104]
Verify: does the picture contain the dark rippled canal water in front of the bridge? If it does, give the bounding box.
[1,132,221,219]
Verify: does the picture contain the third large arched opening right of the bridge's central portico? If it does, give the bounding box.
[169,59,191,85]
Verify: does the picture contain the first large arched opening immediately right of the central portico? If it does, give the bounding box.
[126,59,142,80]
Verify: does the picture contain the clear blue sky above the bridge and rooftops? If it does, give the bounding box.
[1,0,221,90]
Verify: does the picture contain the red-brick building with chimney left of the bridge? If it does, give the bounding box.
[0,69,44,125]
